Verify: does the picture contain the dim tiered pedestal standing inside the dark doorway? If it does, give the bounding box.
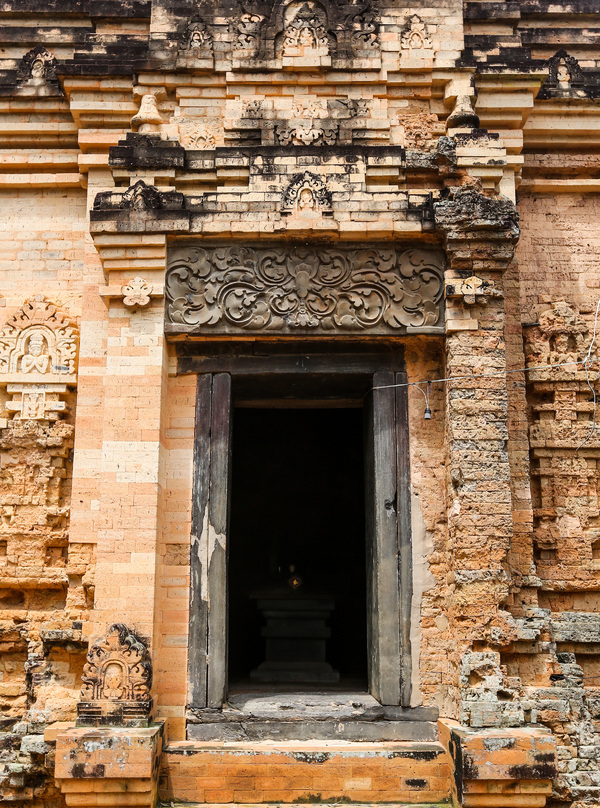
[250,590,340,684]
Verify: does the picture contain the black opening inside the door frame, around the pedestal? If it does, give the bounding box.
[228,408,367,690]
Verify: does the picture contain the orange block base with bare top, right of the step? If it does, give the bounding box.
[438,719,557,808]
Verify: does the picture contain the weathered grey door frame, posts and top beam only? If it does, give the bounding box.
[186,344,412,715]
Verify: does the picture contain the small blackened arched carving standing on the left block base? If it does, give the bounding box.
[77,623,152,726]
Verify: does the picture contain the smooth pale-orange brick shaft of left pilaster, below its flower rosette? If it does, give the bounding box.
[89,299,165,638]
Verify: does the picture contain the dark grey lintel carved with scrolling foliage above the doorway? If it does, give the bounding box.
[166,245,444,336]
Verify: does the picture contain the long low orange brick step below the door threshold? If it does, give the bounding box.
[160,741,451,806]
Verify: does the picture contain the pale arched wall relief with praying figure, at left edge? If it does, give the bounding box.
[0,295,79,381]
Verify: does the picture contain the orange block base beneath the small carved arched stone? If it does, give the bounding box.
[54,721,164,808]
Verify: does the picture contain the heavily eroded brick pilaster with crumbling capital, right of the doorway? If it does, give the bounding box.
[435,189,518,720]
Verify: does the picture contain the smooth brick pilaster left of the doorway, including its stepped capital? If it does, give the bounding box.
[73,177,173,641]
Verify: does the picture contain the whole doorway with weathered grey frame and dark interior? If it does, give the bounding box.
[186,352,412,720]
